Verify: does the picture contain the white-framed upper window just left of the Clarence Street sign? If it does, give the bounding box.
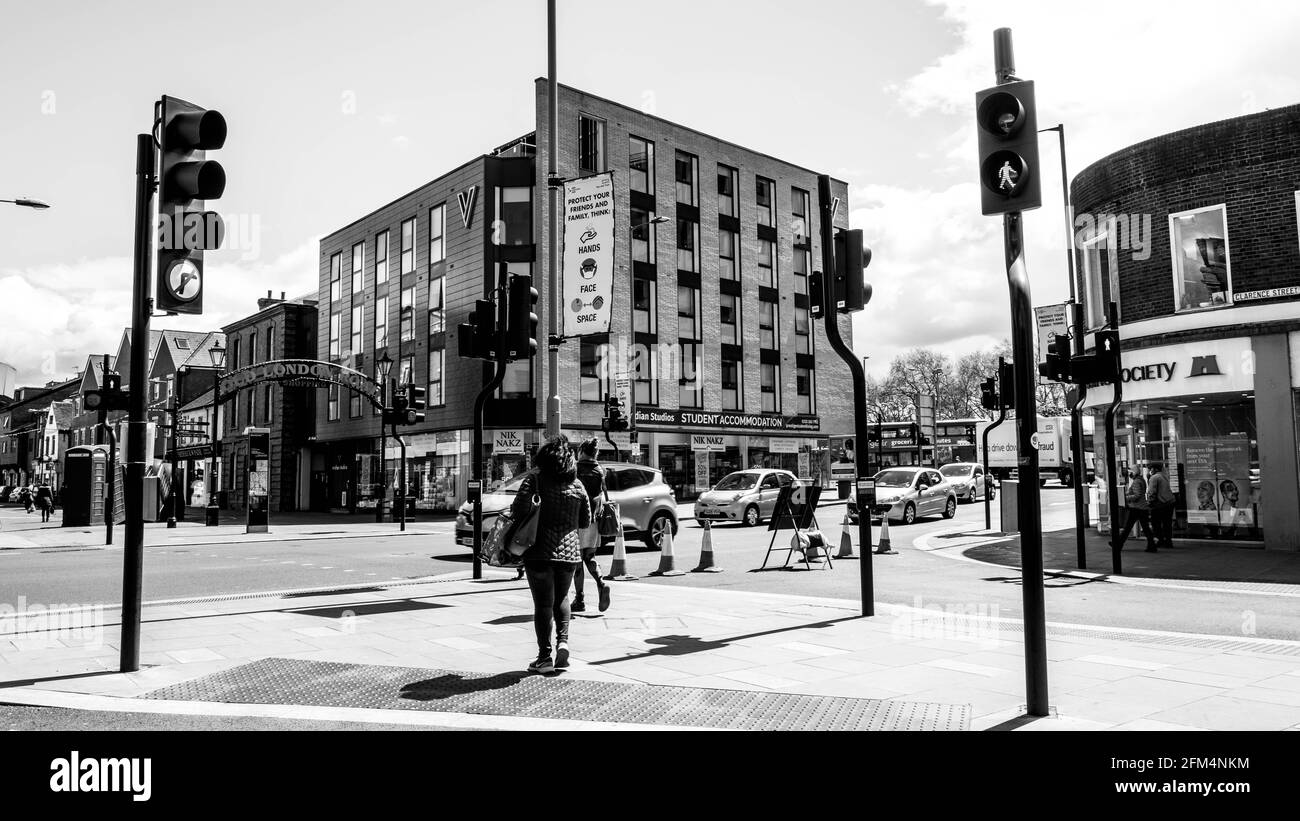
[1169,205,1232,310]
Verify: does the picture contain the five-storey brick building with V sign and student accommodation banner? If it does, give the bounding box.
[312,79,853,509]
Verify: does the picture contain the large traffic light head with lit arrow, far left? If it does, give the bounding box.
[155,96,226,313]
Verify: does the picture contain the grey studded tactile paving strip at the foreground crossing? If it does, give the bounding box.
[140,659,970,730]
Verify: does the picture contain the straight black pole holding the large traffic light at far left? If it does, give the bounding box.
[121,134,155,673]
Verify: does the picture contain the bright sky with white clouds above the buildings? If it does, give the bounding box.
[0,0,1300,385]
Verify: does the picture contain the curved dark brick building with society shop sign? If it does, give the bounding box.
[1071,105,1300,549]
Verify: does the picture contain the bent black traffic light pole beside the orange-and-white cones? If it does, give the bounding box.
[816,174,876,616]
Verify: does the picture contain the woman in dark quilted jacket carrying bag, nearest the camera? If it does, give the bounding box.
[511,435,592,674]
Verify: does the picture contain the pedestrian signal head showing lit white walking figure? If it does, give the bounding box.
[975,81,1043,217]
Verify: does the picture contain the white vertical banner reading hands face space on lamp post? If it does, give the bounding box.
[560,171,615,336]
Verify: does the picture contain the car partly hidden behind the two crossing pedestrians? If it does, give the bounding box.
[456,462,677,549]
